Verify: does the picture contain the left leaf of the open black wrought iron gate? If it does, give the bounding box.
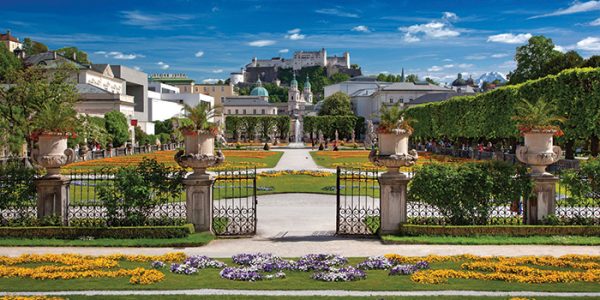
[212,169,257,236]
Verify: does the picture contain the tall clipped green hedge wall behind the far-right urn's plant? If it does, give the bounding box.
[407,68,600,140]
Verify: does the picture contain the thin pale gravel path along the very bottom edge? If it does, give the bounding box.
[0,289,600,297]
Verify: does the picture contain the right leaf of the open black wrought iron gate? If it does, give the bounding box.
[336,167,381,235]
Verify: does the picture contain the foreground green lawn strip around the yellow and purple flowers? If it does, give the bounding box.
[0,253,600,292]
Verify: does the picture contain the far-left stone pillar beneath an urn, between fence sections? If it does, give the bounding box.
[35,178,71,225]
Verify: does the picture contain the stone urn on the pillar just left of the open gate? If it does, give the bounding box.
[175,130,225,178]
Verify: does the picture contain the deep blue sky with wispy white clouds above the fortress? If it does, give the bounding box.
[0,0,600,81]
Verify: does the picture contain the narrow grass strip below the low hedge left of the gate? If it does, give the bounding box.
[0,232,214,247]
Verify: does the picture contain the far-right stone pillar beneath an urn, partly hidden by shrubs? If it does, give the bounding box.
[525,175,558,225]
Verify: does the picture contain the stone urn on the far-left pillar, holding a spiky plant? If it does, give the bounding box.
[32,133,75,179]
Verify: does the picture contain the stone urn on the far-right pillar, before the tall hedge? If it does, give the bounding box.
[516,130,562,176]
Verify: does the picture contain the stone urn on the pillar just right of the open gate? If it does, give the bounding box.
[369,129,419,175]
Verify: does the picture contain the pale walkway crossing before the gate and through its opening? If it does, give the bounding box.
[0,194,600,257]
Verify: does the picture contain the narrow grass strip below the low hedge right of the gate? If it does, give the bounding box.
[381,235,600,246]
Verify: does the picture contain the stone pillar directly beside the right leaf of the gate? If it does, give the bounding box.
[379,172,410,234]
